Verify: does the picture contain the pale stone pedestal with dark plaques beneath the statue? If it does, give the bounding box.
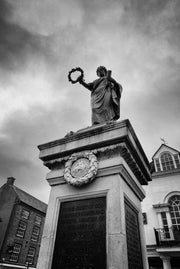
[37,120,150,269]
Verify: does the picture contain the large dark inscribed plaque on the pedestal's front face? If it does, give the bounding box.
[52,197,106,269]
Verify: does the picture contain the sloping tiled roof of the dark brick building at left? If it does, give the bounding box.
[12,185,47,213]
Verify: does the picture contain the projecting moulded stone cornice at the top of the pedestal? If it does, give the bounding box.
[38,120,151,185]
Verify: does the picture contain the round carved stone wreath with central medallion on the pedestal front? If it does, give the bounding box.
[64,152,98,187]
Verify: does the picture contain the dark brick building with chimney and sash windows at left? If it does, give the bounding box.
[0,177,47,268]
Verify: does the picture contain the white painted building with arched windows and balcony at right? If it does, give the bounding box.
[142,144,180,269]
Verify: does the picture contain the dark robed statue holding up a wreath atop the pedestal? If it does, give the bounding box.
[69,66,122,125]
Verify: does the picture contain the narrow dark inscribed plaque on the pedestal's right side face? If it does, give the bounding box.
[125,197,143,269]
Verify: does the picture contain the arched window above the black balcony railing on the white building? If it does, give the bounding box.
[168,195,180,230]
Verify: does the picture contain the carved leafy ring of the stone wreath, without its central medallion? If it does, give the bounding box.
[64,152,98,187]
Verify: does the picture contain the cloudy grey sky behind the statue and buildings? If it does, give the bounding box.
[0,0,180,202]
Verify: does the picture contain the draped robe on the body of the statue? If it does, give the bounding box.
[88,77,122,125]
